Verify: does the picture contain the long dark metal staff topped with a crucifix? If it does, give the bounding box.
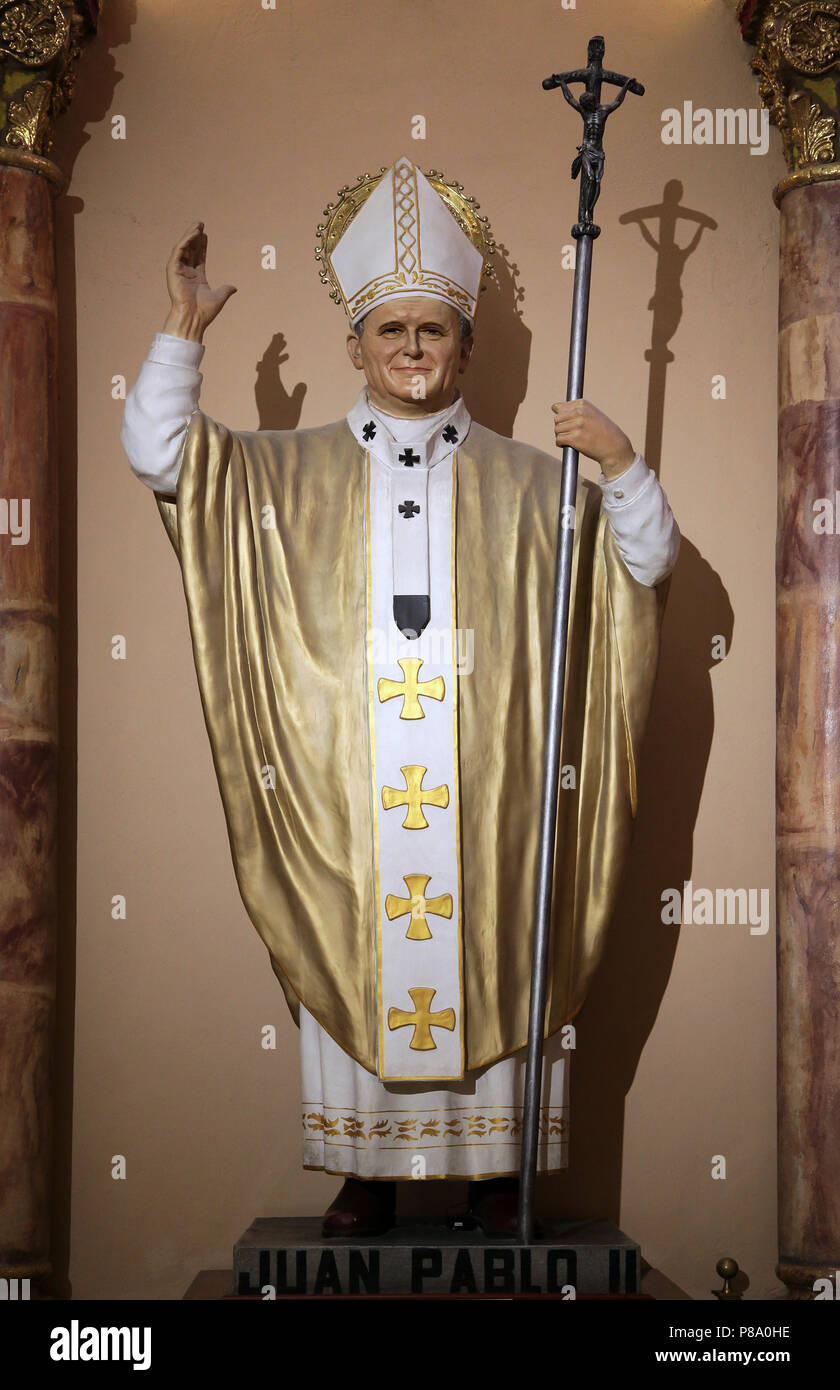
[517,36,644,1245]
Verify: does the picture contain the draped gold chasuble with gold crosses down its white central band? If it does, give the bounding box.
[156,410,669,1080]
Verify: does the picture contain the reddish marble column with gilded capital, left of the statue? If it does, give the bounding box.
[0,0,96,1279]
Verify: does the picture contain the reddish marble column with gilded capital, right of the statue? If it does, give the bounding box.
[740,0,840,1298]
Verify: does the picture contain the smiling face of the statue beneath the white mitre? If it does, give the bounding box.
[348,296,473,417]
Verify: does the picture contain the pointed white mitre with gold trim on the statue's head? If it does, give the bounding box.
[327,156,484,324]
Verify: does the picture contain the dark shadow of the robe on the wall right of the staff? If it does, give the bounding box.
[541,535,733,1234]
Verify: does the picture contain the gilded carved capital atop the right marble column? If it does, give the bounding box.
[738,0,840,206]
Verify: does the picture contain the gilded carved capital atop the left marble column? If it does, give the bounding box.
[0,0,102,192]
